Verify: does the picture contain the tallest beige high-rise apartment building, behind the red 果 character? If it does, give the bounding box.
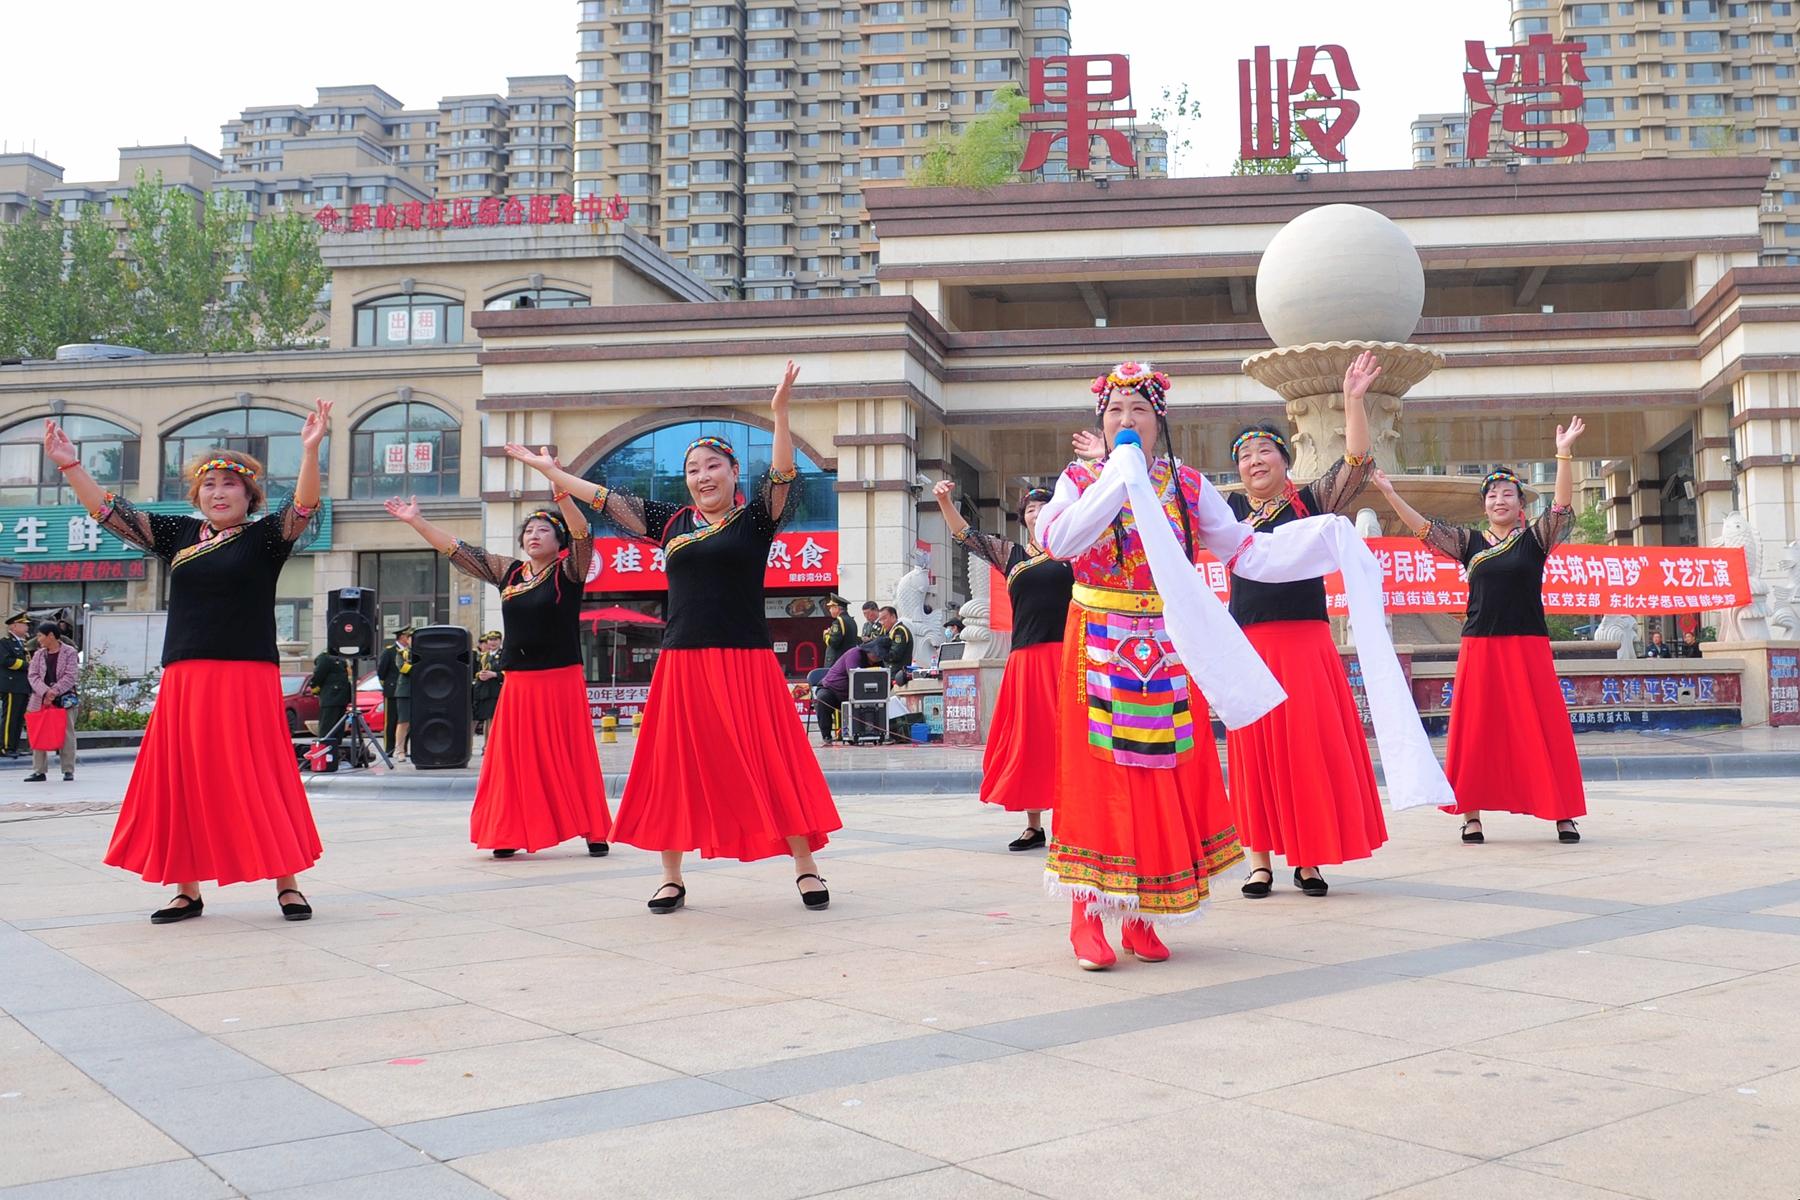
[574,0,1166,299]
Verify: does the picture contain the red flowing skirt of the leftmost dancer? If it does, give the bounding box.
[106,658,320,885]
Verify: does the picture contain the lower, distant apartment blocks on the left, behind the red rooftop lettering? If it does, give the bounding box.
[221,76,574,207]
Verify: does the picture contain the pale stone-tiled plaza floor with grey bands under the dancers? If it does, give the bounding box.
[0,765,1800,1200]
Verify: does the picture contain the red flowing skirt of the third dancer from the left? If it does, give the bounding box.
[612,648,844,862]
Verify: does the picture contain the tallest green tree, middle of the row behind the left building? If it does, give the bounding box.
[121,173,252,354]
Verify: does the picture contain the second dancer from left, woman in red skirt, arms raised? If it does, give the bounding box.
[387,464,612,858]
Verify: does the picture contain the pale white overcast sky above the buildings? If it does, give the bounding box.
[0,0,1508,182]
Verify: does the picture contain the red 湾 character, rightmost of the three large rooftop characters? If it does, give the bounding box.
[1463,34,1588,162]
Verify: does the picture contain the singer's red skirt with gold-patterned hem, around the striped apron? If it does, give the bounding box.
[1044,604,1244,921]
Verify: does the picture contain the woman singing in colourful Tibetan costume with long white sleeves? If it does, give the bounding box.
[1039,363,1449,970]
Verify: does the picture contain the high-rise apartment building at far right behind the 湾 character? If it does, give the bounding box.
[1413,0,1800,264]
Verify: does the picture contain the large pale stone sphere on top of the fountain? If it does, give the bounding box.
[1256,203,1426,345]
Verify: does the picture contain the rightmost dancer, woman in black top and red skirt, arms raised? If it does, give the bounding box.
[1375,417,1588,842]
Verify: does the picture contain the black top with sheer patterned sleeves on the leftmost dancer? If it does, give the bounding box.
[95,497,311,666]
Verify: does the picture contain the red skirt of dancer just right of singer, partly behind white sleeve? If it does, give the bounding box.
[1226,621,1388,867]
